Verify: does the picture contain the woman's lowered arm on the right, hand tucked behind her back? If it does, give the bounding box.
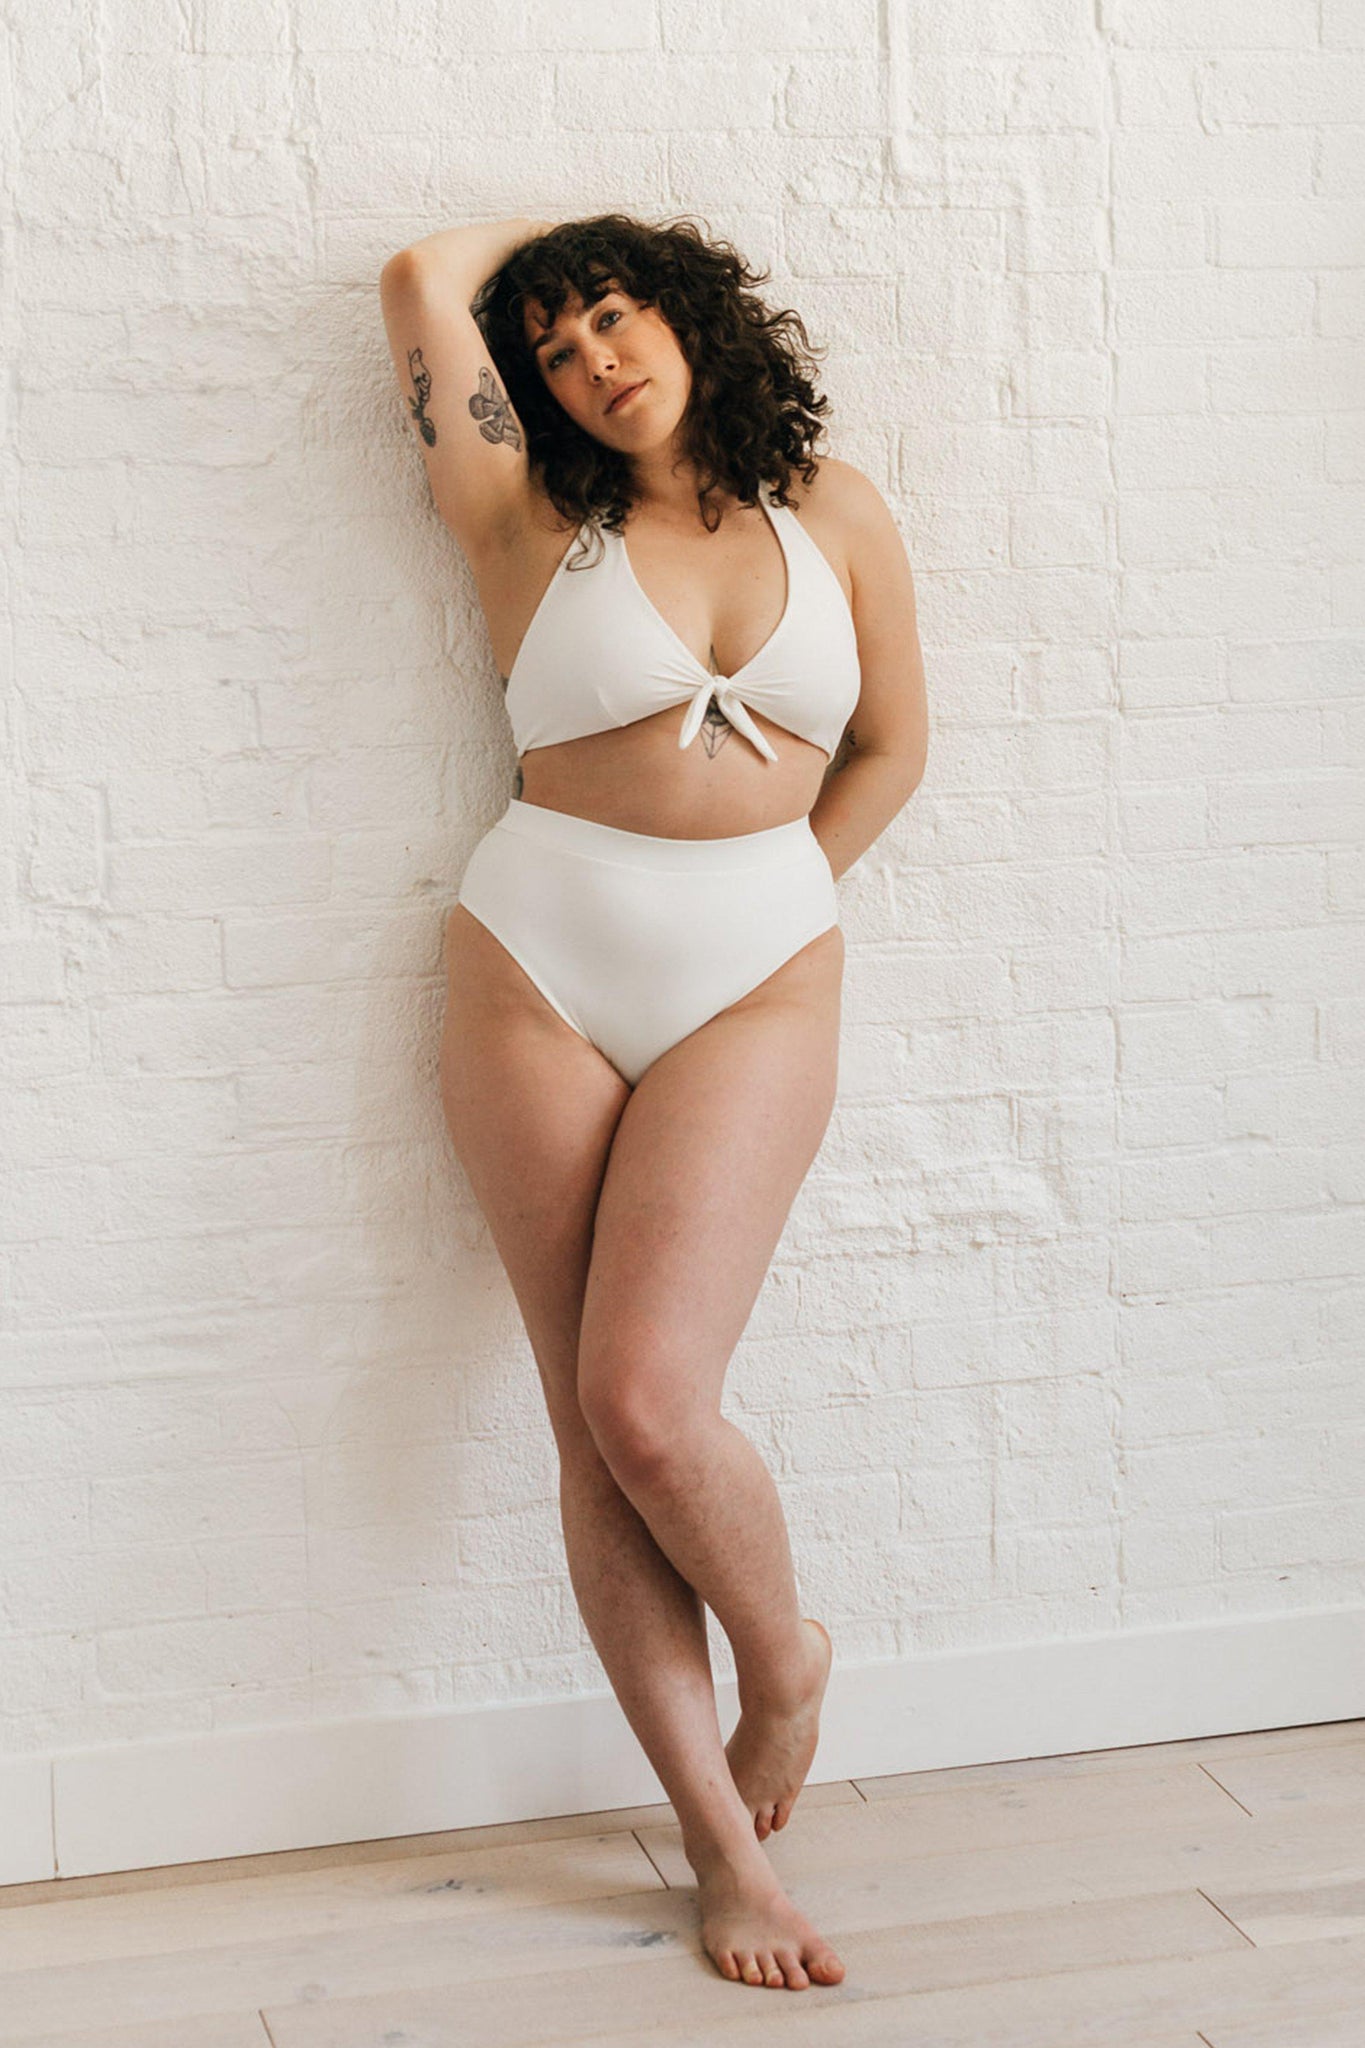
[810,461,929,877]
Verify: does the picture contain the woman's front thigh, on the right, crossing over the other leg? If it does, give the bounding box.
[579,926,843,1436]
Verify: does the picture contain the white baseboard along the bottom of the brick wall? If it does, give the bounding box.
[0,1608,1365,1884]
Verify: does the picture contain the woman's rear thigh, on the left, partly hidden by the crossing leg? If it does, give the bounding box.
[440,903,630,1444]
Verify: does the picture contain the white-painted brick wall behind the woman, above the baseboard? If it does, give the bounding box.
[0,0,1365,1751]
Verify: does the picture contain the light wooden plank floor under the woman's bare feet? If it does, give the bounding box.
[0,1720,1365,2048]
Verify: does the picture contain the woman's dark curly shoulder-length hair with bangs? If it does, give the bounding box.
[471,213,829,561]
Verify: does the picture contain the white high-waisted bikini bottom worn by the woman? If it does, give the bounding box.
[458,797,839,1087]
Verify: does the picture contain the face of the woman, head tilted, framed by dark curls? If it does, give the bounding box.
[524,287,692,455]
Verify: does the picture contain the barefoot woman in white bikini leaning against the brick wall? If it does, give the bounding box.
[381,215,927,1989]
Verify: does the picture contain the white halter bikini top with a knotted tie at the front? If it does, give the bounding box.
[508,485,862,762]
